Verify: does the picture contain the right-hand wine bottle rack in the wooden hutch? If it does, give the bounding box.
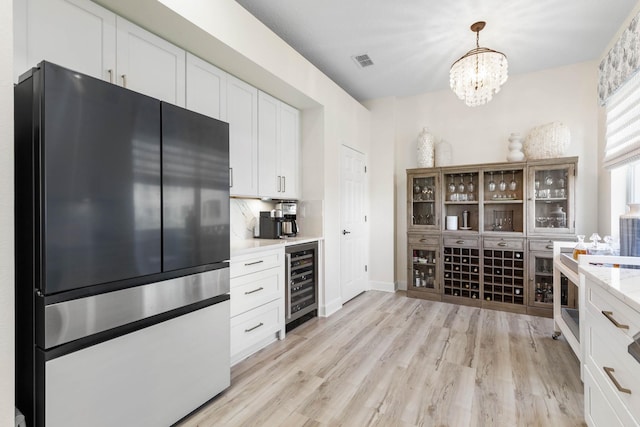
[483,249,525,305]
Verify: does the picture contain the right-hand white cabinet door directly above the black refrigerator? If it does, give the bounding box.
[116,17,186,107]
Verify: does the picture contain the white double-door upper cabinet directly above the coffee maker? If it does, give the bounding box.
[258,92,300,199]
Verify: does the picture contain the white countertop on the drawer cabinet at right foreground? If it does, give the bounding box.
[580,265,640,311]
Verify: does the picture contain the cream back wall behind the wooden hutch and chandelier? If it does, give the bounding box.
[368,62,598,289]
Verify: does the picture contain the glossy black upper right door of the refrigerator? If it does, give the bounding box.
[162,103,229,271]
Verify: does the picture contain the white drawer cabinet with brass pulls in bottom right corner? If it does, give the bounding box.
[584,278,640,427]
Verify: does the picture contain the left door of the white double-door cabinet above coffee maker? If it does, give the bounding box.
[258,92,282,199]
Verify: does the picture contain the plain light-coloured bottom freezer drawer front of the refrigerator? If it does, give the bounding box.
[45,300,230,427]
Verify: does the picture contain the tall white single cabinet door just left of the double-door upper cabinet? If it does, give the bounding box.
[227,75,258,197]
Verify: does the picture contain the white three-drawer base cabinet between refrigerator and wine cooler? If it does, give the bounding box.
[231,248,285,365]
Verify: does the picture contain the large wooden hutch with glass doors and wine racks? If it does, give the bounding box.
[407,157,578,317]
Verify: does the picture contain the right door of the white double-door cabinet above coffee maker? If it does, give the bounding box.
[278,102,300,199]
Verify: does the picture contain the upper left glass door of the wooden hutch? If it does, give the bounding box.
[407,171,440,231]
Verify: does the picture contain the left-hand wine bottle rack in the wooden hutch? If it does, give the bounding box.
[442,246,480,300]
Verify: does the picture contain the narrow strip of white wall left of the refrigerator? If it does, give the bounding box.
[0,0,15,426]
